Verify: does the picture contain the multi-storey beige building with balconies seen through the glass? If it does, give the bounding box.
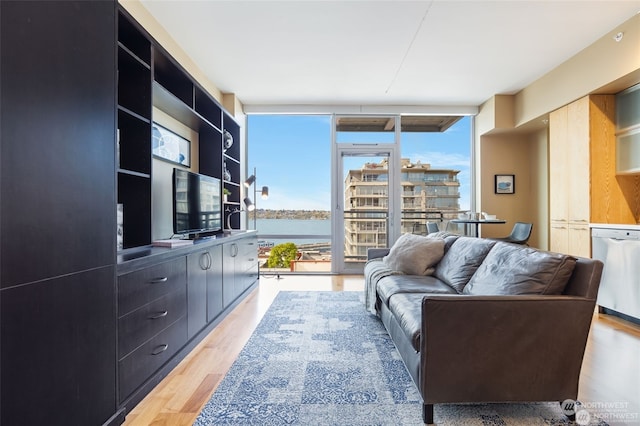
[344,158,460,261]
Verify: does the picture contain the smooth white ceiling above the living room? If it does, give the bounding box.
[141,0,640,106]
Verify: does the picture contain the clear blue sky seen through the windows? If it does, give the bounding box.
[248,115,471,210]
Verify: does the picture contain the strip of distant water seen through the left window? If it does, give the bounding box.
[256,219,331,245]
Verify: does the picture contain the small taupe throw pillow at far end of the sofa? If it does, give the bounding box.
[383,234,444,275]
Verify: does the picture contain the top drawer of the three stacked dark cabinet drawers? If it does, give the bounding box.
[118,257,187,316]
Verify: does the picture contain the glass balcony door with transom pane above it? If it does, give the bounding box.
[331,116,400,274]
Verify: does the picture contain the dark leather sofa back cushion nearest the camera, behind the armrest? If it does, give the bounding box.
[463,242,576,295]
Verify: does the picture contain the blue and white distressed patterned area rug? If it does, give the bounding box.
[194,292,605,426]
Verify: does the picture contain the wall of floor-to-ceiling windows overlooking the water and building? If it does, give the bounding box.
[246,115,472,272]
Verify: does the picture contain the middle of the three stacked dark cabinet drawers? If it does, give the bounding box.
[118,287,187,359]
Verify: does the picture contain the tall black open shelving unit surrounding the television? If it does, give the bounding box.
[116,10,243,249]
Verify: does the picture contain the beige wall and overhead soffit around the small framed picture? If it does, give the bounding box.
[474,15,640,249]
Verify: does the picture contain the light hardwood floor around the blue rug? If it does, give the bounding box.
[125,275,640,426]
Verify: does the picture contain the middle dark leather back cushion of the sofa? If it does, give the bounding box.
[433,237,496,293]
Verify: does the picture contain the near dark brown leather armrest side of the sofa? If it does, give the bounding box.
[420,295,595,404]
